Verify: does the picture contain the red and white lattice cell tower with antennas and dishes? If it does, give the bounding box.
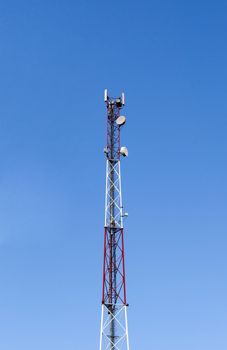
[99,90,129,350]
